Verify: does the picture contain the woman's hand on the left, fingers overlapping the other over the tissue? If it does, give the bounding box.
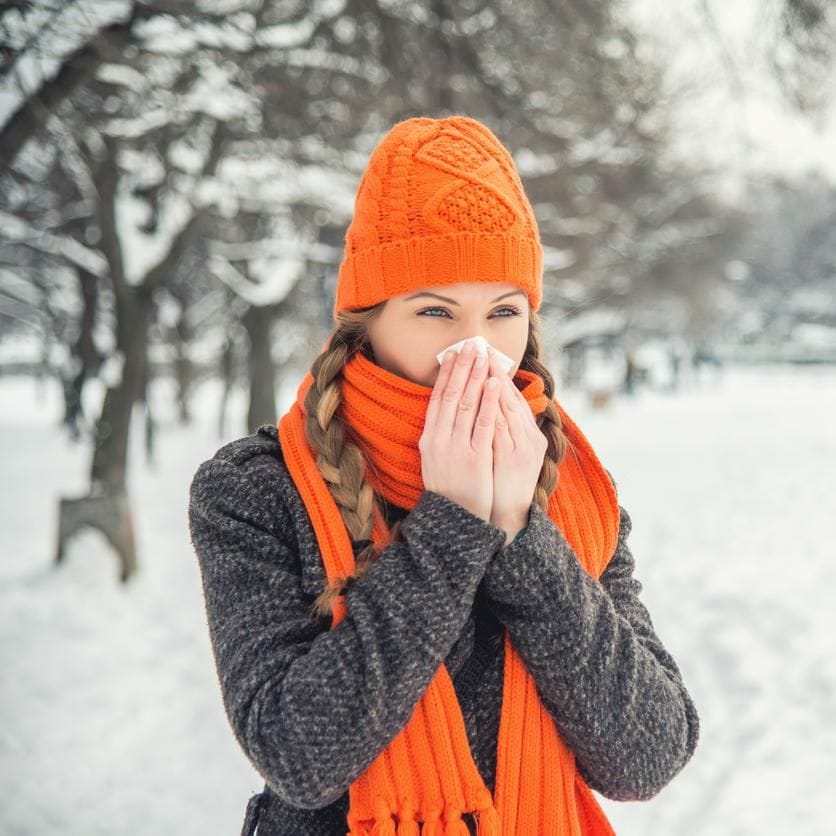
[418,342,499,522]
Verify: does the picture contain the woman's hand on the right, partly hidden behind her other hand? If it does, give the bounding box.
[488,349,548,544]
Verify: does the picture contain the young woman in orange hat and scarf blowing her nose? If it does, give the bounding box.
[189,116,699,836]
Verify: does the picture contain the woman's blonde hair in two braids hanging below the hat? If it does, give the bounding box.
[305,301,569,616]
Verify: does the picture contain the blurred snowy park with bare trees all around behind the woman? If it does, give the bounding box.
[0,0,836,836]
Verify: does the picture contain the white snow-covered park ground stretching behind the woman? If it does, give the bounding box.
[0,368,836,836]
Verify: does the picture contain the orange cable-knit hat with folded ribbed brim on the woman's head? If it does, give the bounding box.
[334,116,543,319]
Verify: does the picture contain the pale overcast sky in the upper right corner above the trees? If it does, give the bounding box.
[627,0,836,184]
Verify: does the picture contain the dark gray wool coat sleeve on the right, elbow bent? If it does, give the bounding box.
[482,503,699,801]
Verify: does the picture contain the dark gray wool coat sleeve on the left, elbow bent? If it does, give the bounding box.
[189,456,504,809]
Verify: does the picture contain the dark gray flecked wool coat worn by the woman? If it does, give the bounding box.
[188,424,699,836]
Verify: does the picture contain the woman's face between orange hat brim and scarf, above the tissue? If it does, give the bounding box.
[369,282,528,387]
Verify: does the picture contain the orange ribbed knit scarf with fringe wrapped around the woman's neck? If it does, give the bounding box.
[277,354,619,836]
